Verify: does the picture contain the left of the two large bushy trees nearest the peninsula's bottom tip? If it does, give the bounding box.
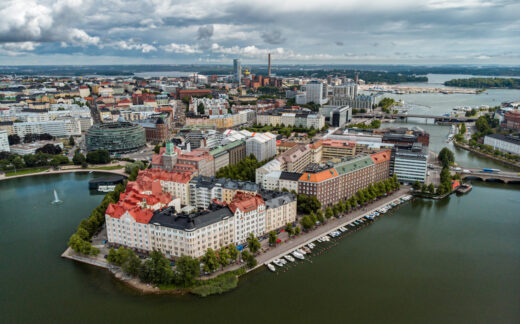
[139,250,173,285]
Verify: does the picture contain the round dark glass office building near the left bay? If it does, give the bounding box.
[85,122,146,153]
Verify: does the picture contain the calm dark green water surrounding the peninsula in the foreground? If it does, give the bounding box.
[0,174,520,323]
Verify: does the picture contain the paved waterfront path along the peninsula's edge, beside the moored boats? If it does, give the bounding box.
[61,186,410,295]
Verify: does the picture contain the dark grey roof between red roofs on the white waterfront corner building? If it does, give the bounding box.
[150,205,233,231]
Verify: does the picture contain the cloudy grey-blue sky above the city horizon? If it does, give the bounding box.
[0,0,520,65]
